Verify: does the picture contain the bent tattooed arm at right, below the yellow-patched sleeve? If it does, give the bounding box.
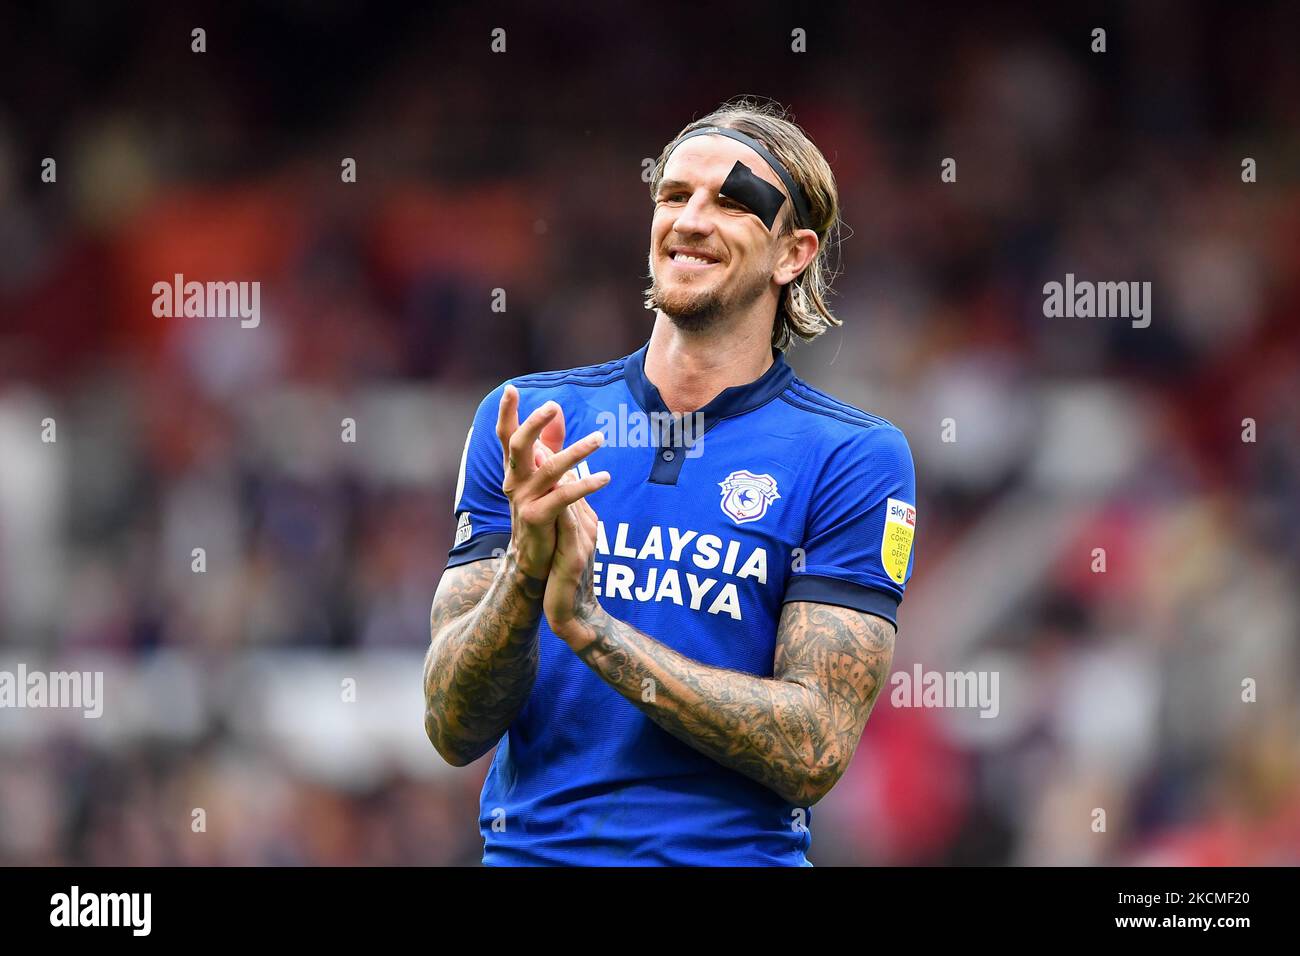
[571,601,894,806]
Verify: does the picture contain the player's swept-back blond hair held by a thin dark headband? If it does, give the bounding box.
[645,96,842,349]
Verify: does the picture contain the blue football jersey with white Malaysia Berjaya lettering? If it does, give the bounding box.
[447,346,917,866]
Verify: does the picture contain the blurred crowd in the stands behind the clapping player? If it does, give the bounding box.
[0,4,1300,865]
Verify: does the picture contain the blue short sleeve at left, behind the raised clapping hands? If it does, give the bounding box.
[447,382,510,567]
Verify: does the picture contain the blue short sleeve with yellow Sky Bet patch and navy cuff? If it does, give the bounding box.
[785,425,917,626]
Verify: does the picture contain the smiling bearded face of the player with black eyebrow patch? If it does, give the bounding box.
[650,135,789,330]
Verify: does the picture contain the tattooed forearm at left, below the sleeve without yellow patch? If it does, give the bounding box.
[424,554,546,766]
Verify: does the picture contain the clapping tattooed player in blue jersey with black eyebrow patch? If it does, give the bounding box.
[424,100,917,866]
